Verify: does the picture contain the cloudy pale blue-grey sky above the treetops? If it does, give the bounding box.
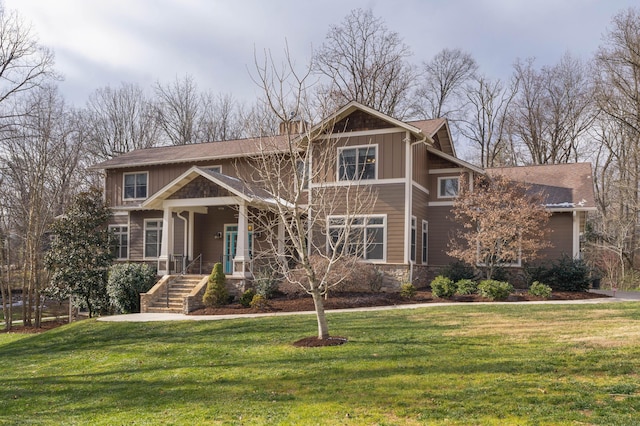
[6,0,640,106]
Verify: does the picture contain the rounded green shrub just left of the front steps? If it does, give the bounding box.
[107,263,156,314]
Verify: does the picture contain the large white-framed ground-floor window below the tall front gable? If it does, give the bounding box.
[328,216,386,260]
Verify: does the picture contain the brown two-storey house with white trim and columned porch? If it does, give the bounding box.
[95,102,595,310]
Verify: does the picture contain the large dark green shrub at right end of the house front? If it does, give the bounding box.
[527,255,591,291]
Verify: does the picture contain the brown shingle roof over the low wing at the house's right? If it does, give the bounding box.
[486,163,596,211]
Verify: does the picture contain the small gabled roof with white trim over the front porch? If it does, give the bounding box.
[142,166,286,209]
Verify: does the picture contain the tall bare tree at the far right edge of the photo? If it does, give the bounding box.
[593,9,640,278]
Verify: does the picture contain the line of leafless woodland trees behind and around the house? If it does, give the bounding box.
[0,3,640,323]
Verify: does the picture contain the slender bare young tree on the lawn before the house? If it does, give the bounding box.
[246,47,376,339]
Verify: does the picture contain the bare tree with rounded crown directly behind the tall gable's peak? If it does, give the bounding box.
[313,9,415,118]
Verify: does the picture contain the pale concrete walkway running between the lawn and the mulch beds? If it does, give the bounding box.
[98,290,640,322]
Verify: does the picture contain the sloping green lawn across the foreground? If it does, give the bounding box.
[0,303,640,425]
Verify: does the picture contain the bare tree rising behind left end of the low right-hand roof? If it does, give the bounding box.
[460,77,516,167]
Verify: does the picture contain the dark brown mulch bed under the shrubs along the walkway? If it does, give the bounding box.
[191,291,606,315]
